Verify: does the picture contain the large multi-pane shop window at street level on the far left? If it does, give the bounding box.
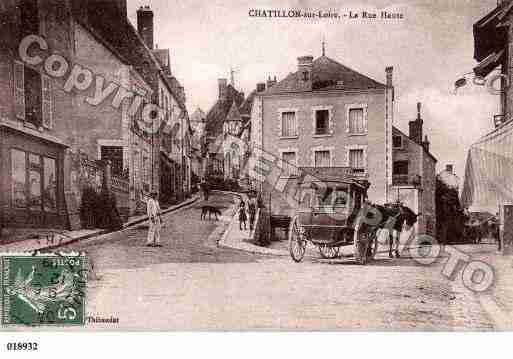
[11,149,58,212]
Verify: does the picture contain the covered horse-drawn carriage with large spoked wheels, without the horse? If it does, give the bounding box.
[289,169,375,264]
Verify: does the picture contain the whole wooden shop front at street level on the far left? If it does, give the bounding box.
[0,126,67,228]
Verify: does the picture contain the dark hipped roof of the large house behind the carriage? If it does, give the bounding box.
[263,56,386,95]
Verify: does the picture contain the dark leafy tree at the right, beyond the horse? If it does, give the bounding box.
[435,176,465,243]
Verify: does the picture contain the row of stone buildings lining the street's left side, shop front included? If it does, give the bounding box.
[0,0,190,227]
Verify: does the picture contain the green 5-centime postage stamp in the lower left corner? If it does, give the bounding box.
[0,253,88,326]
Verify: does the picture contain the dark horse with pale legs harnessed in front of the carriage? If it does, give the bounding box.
[363,203,420,258]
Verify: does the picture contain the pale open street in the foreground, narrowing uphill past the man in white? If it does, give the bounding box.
[59,195,513,330]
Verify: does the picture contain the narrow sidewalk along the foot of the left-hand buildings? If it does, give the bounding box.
[0,196,199,253]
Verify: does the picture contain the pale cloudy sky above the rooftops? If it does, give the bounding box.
[128,0,499,180]
